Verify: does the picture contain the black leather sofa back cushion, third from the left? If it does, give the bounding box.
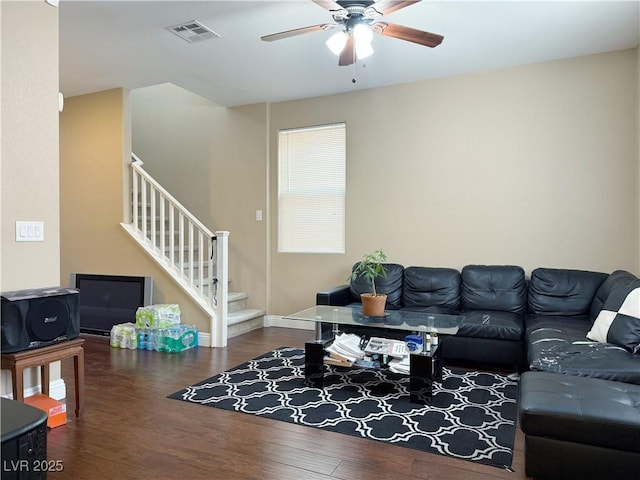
[461,265,527,313]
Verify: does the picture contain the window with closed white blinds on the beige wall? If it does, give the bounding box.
[278,123,346,253]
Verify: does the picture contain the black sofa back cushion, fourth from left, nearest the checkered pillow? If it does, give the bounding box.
[529,268,607,315]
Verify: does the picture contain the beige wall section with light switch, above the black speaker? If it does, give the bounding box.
[0,1,60,395]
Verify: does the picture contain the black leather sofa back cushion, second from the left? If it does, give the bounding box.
[402,267,460,311]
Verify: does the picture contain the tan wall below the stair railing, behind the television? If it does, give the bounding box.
[60,89,209,332]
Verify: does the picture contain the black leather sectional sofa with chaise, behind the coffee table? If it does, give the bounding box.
[316,264,640,479]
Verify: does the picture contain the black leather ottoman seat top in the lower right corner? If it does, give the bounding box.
[519,372,640,454]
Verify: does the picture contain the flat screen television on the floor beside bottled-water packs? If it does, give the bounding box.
[71,273,153,335]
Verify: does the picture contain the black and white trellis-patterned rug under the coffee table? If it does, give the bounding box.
[169,347,518,468]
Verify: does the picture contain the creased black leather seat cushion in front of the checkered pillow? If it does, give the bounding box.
[525,315,640,384]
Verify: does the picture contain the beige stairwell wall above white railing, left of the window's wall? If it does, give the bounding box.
[131,84,267,308]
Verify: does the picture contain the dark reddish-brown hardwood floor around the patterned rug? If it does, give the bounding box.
[47,328,526,480]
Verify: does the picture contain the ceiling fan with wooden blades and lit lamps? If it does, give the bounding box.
[260,0,444,66]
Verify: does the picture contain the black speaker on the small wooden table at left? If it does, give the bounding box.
[2,287,80,353]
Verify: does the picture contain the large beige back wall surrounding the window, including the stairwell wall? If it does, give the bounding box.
[67,49,640,322]
